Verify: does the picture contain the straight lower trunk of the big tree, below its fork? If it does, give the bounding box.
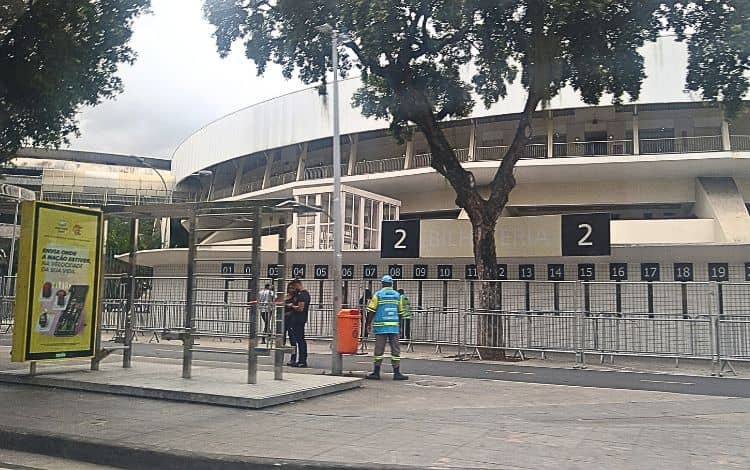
[470,220,505,360]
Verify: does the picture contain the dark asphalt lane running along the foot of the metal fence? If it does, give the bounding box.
[117,343,750,398]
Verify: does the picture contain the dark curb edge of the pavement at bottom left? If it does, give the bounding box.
[0,427,424,470]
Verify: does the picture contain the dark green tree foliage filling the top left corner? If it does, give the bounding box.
[0,0,150,162]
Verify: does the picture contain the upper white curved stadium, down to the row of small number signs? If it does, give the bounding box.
[159,42,750,290]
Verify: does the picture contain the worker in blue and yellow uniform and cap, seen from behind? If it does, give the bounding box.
[366,275,409,380]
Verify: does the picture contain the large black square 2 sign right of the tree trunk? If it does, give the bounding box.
[562,214,611,256]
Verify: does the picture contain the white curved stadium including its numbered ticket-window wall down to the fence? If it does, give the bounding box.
[4,42,750,357]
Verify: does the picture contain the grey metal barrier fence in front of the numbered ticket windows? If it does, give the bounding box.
[0,275,750,370]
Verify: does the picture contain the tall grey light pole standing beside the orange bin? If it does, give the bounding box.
[317,24,346,375]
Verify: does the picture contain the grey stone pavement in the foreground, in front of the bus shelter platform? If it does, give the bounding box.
[0,358,750,470]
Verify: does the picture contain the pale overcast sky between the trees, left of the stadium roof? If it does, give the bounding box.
[70,0,304,158]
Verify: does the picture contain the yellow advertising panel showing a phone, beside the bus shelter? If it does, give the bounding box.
[11,201,102,362]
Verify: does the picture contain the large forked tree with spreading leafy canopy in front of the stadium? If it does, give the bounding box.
[204,0,750,352]
